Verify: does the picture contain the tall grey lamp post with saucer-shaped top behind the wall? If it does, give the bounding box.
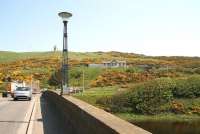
[58,12,72,96]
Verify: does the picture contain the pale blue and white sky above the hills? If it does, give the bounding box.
[0,0,200,56]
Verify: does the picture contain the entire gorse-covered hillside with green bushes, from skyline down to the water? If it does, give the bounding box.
[0,52,200,121]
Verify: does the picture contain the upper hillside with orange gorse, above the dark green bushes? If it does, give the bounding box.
[0,51,200,87]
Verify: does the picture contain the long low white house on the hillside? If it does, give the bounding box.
[89,60,127,68]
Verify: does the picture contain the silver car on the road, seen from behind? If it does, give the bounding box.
[13,87,32,100]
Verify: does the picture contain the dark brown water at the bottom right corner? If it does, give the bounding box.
[133,121,200,134]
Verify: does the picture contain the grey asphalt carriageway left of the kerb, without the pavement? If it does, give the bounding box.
[0,97,35,134]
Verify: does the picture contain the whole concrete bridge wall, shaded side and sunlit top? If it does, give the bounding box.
[43,91,150,134]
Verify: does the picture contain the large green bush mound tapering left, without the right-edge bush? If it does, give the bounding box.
[97,78,175,114]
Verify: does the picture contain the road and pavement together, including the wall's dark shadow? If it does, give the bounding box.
[0,94,66,134]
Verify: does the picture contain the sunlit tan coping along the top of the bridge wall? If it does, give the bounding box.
[63,95,151,134]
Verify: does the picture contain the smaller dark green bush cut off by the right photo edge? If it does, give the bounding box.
[173,76,200,98]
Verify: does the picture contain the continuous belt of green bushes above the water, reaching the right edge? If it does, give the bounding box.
[97,76,200,114]
